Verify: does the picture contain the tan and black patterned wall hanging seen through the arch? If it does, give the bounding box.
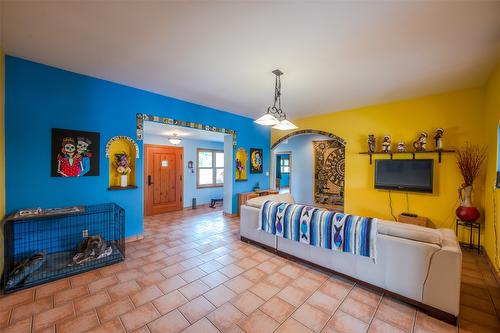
[313,140,345,207]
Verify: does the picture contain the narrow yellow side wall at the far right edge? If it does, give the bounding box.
[483,66,500,270]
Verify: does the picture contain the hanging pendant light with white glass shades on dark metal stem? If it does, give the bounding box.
[255,69,298,131]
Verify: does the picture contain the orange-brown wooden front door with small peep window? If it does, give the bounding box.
[144,145,184,216]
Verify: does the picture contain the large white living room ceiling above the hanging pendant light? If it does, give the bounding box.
[2,1,500,119]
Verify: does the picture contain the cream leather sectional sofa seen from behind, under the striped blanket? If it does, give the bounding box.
[240,195,462,323]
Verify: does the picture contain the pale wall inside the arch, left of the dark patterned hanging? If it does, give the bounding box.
[273,134,329,205]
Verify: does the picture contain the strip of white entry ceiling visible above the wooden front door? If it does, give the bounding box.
[144,121,229,142]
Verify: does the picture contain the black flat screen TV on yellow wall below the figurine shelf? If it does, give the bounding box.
[375,159,434,193]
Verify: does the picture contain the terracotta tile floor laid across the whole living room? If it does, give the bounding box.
[0,208,500,333]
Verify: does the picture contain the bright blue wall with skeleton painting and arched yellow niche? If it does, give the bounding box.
[5,56,270,237]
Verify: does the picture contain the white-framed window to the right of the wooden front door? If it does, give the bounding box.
[196,149,224,188]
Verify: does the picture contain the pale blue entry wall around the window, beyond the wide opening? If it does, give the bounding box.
[144,134,226,207]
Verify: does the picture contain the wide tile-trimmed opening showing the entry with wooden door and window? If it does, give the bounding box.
[144,121,233,216]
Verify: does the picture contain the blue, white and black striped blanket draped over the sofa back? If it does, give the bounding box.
[259,201,377,259]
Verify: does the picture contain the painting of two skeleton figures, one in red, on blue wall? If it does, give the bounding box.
[50,128,100,177]
